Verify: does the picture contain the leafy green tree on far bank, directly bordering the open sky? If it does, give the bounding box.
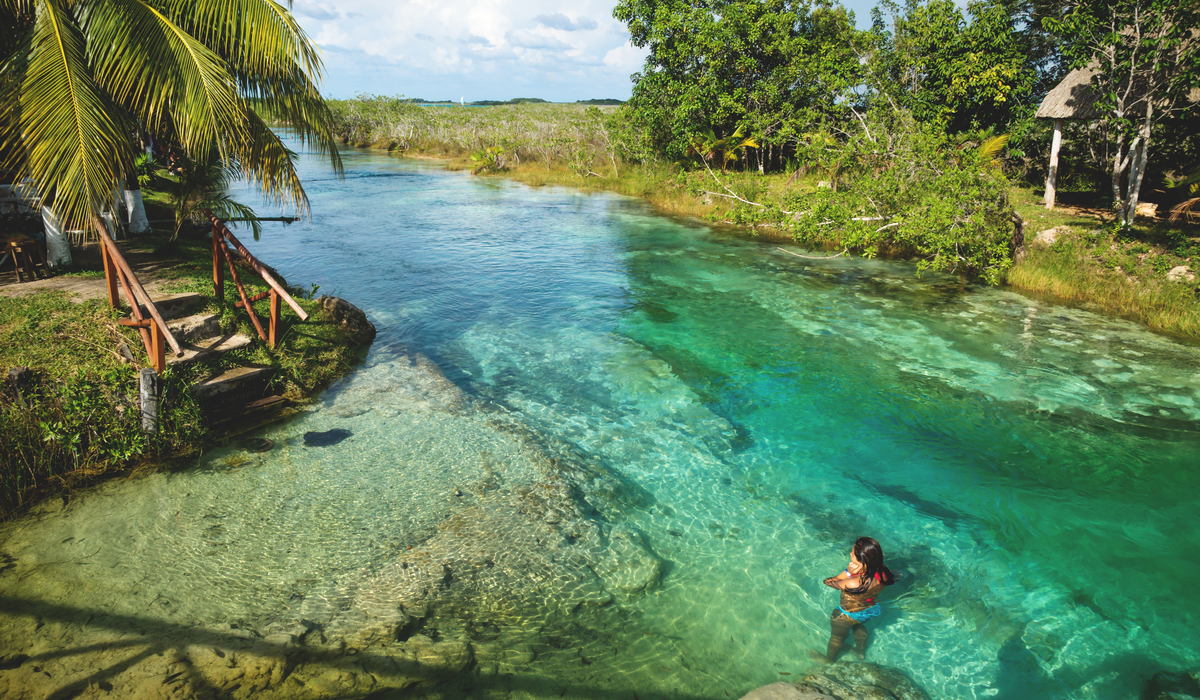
[613,0,862,166]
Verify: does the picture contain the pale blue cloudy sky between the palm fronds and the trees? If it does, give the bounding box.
[292,0,875,102]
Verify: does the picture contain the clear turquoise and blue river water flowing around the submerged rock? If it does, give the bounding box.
[0,145,1200,698]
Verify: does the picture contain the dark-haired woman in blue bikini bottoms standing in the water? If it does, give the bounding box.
[811,537,895,663]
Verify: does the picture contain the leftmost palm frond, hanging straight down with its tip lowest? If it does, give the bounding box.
[12,0,133,228]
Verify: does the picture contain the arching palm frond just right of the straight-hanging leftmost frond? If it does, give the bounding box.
[83,0,246,160]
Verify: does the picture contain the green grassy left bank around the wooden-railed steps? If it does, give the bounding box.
[0,202,359,516]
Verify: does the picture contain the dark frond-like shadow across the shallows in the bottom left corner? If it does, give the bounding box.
[0,596,721,700]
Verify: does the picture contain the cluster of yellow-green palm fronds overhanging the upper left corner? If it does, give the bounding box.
[0,0,338,228]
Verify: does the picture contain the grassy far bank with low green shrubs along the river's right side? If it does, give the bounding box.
[330,95,1200,341]
